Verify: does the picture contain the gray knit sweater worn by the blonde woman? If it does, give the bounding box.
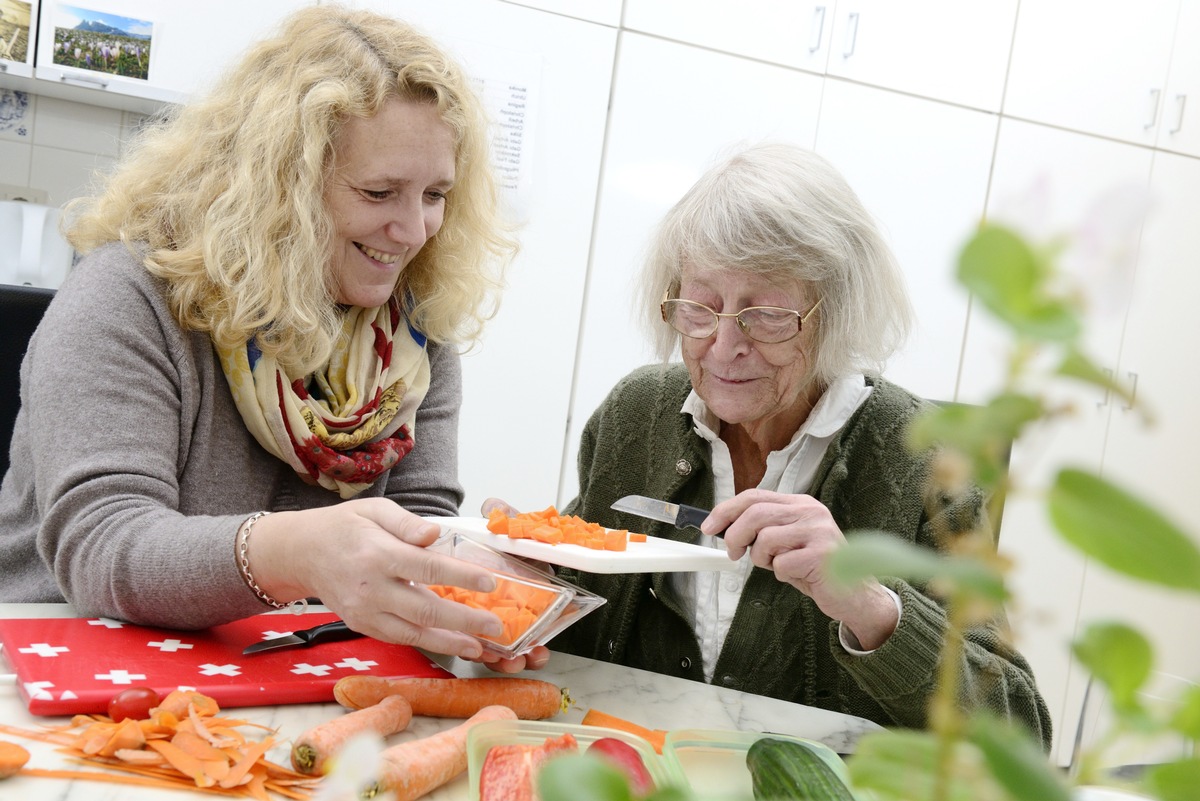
[0,245,462,628]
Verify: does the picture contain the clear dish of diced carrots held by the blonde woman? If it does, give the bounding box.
[428,531,605,658]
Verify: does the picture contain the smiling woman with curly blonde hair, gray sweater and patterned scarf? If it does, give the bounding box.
[0,6,523,664]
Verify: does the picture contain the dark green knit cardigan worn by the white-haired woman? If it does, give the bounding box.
[551,365,1051,748]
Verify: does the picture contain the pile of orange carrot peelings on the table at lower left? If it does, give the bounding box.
[0,689,319,801]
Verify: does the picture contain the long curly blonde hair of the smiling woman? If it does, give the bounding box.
[67,5,517,373]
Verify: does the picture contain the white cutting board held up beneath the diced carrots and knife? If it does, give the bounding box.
[425,517,736,573]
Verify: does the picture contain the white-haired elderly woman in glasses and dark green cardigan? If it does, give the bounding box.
[552,144,1050,747]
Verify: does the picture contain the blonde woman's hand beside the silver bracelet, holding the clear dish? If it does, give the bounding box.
[250,498,503,660]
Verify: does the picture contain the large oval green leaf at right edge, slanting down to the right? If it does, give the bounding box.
[1049,469,1200,592]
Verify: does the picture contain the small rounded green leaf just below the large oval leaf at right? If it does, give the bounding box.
[1072,621,1154,715]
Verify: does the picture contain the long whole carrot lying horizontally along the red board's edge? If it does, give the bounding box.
[334,676,571,721]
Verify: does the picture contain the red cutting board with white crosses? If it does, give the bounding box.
[0,612,454,715]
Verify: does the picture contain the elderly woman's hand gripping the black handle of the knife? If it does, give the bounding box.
[702,489,899,650]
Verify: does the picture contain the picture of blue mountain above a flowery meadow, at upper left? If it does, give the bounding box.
[51,0,154,80]
